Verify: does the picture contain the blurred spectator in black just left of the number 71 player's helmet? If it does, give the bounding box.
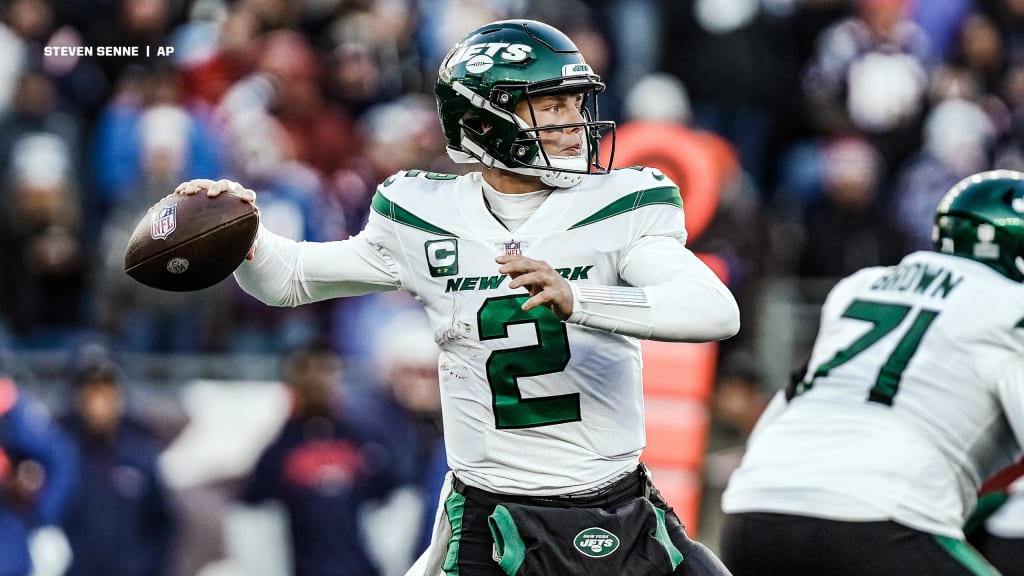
[799,133,907,288]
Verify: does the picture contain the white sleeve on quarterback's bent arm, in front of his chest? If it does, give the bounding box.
[567,236,739,342]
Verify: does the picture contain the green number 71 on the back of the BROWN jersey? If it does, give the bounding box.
[802,300,939,406]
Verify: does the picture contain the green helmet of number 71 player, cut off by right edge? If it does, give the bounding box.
[932,170,1024,282]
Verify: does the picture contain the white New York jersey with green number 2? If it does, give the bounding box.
[360,169,685,495]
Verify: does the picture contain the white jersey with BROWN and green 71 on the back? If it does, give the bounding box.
[722,252,1024,538]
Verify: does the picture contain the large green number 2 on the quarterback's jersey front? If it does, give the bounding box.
[476,295,580,428]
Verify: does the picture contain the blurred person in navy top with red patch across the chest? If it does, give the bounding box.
[242,344,397,576]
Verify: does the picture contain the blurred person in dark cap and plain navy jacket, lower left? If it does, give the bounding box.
[60,347,176,576]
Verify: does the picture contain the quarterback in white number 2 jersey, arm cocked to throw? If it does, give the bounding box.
[178,20,739,576]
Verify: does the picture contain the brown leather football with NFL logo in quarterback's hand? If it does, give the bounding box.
[125,193,259,292]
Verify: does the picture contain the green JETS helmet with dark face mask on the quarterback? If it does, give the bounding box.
[434,19,615,188]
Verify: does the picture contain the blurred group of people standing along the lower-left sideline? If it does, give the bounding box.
[0,311,447,576]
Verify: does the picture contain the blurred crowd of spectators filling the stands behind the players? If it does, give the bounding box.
[0,0,1024,357]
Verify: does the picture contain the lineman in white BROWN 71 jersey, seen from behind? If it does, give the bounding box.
[722,170,1024,576]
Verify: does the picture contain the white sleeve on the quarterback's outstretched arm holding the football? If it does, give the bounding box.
[234,225,400,306]
